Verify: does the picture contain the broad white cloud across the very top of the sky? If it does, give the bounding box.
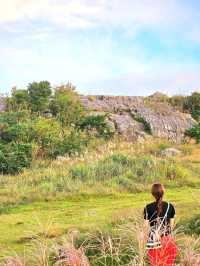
[0,0,196,31]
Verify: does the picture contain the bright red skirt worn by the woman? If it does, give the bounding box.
[147,235,177,266]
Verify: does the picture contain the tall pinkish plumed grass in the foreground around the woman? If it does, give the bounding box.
[0,214,200,266]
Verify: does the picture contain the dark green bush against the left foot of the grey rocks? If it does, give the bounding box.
[78,115,113,139]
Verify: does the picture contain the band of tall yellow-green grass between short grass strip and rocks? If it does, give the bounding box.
[0,139,200,212]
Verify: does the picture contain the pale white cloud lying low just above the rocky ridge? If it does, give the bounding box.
[80,62,200,96]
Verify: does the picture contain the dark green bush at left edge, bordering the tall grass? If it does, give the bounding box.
[0,143,32,174]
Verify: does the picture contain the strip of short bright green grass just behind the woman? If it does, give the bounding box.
[0,188,200,254]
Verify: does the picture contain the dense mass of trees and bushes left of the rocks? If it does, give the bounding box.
[0,81,111,174]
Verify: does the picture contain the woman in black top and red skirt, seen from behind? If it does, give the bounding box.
[144,183,176,266]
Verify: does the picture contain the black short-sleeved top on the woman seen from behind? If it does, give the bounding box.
[144,201,175,234]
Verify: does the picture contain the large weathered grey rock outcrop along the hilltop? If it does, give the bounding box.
[80,96,196,143]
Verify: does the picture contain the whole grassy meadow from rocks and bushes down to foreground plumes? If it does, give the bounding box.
[0,138,200,265]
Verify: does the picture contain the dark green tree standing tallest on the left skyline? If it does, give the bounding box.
[28,81,52,113]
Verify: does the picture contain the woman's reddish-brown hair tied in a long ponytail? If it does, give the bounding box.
[151,183,165,216]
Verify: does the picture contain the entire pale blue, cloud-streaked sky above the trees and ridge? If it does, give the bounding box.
[0,0,200,95]
